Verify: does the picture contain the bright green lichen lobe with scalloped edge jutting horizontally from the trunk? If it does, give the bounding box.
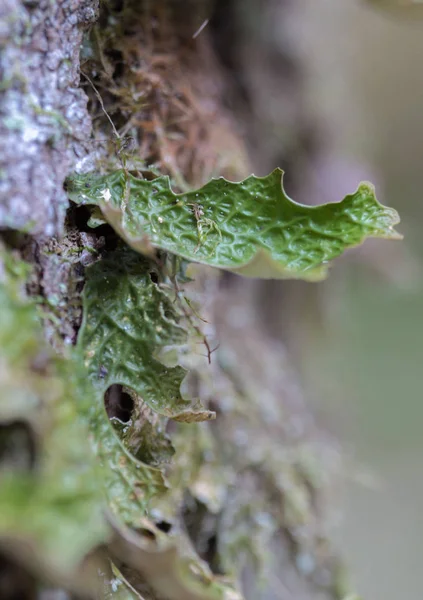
[67,169,401,281]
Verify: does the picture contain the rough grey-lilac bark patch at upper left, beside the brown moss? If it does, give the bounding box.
[0,0,98,236]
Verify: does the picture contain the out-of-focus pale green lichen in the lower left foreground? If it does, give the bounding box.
[0,248,109,578]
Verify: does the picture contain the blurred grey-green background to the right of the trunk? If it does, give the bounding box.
[297,0,423,600]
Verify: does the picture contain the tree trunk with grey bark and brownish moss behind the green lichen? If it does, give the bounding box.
[0,0,348,600]
